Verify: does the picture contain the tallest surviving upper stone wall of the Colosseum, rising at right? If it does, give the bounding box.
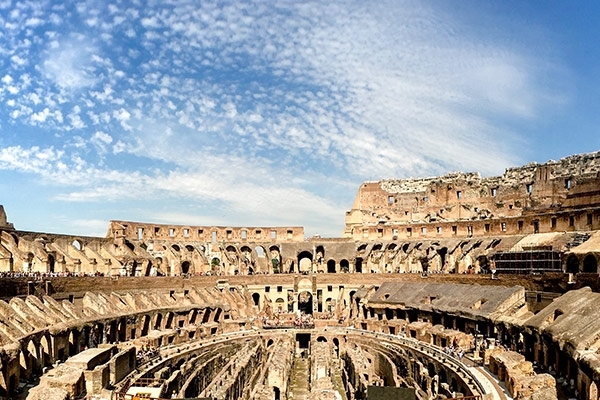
[344,152,600,240]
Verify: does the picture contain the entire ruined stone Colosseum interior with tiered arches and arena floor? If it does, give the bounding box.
[0,152,600,400]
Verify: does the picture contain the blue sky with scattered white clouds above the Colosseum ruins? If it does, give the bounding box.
[0,0,600,237]
